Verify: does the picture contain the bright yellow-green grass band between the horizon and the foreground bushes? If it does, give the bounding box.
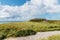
[0,22,60,32]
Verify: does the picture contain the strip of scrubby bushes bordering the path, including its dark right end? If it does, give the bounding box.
[0,28,36,40]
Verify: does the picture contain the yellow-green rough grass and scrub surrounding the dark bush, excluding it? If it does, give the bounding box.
[0,21,60,39]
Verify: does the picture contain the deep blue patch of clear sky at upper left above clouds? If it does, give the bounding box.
[0,0,29,6]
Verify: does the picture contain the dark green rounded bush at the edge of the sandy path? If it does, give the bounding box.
[16,30,36,37]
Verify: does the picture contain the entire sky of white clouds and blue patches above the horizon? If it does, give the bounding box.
[0,0,60,21]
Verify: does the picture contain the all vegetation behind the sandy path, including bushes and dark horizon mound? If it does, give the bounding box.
[0,19,60,40]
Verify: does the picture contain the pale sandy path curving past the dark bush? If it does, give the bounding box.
[5,31,60,40]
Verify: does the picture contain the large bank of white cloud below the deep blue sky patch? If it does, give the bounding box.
[0,0,60,20]
